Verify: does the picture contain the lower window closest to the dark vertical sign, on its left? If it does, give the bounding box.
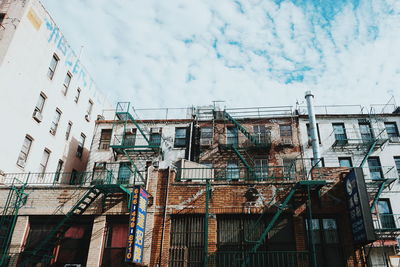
[305,218,344,267]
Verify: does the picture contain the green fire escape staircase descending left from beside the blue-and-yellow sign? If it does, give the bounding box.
[19,184,131,266]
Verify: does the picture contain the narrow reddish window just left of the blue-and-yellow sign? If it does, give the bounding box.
[101,218,129,267]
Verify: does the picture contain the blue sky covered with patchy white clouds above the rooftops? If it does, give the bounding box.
[43,0,400,108]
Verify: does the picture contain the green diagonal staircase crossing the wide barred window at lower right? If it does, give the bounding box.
[242,180,326,267]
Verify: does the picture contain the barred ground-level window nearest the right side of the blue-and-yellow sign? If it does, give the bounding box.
[170,215,204,266]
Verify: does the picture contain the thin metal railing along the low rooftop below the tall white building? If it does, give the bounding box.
[0,169,144,186]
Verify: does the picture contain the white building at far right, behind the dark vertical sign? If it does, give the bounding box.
[299,101,400,266]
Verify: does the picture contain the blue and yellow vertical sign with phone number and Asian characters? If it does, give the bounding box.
[125,186,149,263]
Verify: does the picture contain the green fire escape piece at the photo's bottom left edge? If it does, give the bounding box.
[0,178,29,266]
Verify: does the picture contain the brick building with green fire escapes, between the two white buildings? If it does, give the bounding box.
[0,103,398,266]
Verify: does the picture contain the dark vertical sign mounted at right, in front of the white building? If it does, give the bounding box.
[344,168,375,245]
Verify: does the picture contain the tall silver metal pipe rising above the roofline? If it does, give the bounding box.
[305,91,321,171]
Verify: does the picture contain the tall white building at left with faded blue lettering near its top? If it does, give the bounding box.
[0,0,111,182]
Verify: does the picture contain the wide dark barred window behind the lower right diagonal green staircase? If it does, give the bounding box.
[216,217,296,266]
